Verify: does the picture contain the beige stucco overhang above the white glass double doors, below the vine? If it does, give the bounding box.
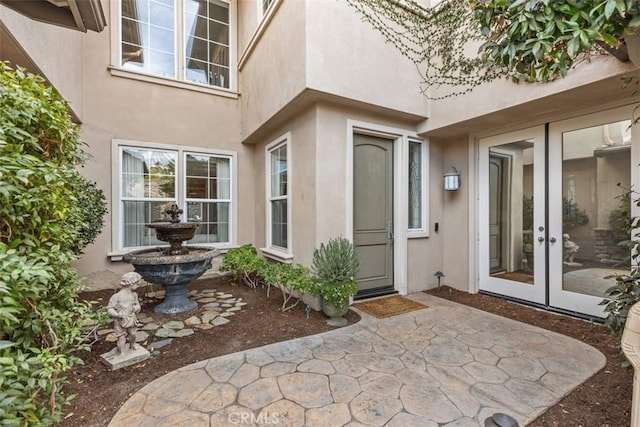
[420,55,637,136]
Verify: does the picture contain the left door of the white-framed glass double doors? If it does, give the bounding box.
[479,128,546,303]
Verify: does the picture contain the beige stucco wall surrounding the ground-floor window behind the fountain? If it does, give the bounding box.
[76,1,245,275]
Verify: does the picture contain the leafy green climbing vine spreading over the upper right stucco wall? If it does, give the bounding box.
[347,0,640,99]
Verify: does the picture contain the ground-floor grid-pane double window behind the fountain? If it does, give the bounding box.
[114,141,236,251]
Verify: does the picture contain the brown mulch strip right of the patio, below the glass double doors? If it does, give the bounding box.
[427,286,633,427]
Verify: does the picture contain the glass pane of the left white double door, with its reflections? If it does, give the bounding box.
[488,141,534,284]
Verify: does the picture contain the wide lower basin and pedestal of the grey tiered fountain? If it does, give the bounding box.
[122,246,220,314]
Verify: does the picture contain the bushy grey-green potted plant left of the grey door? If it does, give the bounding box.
[312,237,360,326]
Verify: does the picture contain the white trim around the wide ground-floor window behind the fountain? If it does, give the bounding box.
[107,139,238,261]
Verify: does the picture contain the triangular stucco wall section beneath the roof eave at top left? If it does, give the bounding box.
[0,4,84,120]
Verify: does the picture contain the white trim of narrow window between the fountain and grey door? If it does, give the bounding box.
[260,132,293,263]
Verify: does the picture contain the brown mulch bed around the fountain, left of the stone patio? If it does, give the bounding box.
[61,277,360,427]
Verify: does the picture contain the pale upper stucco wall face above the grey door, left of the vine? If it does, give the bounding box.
[306,0,428,117]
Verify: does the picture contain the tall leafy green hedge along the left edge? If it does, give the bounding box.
[0,63,105,426]
